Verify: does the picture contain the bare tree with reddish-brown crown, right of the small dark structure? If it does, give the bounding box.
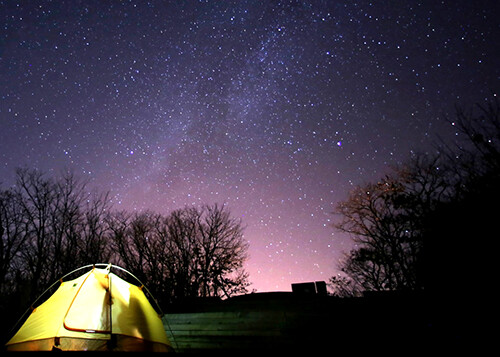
[333,155,449,291]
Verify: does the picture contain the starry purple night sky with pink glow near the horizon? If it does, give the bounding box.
[0,0,500,291]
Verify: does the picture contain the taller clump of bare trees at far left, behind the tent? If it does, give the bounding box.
[0,168,110,340]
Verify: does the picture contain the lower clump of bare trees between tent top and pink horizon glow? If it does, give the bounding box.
[109,205,249,302]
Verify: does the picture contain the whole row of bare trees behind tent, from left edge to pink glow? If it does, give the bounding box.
[0,169,249,336]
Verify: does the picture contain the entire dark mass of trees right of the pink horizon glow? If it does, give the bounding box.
[330,97,500,300]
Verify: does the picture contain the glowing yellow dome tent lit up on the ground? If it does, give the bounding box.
[7,265,173,352]
